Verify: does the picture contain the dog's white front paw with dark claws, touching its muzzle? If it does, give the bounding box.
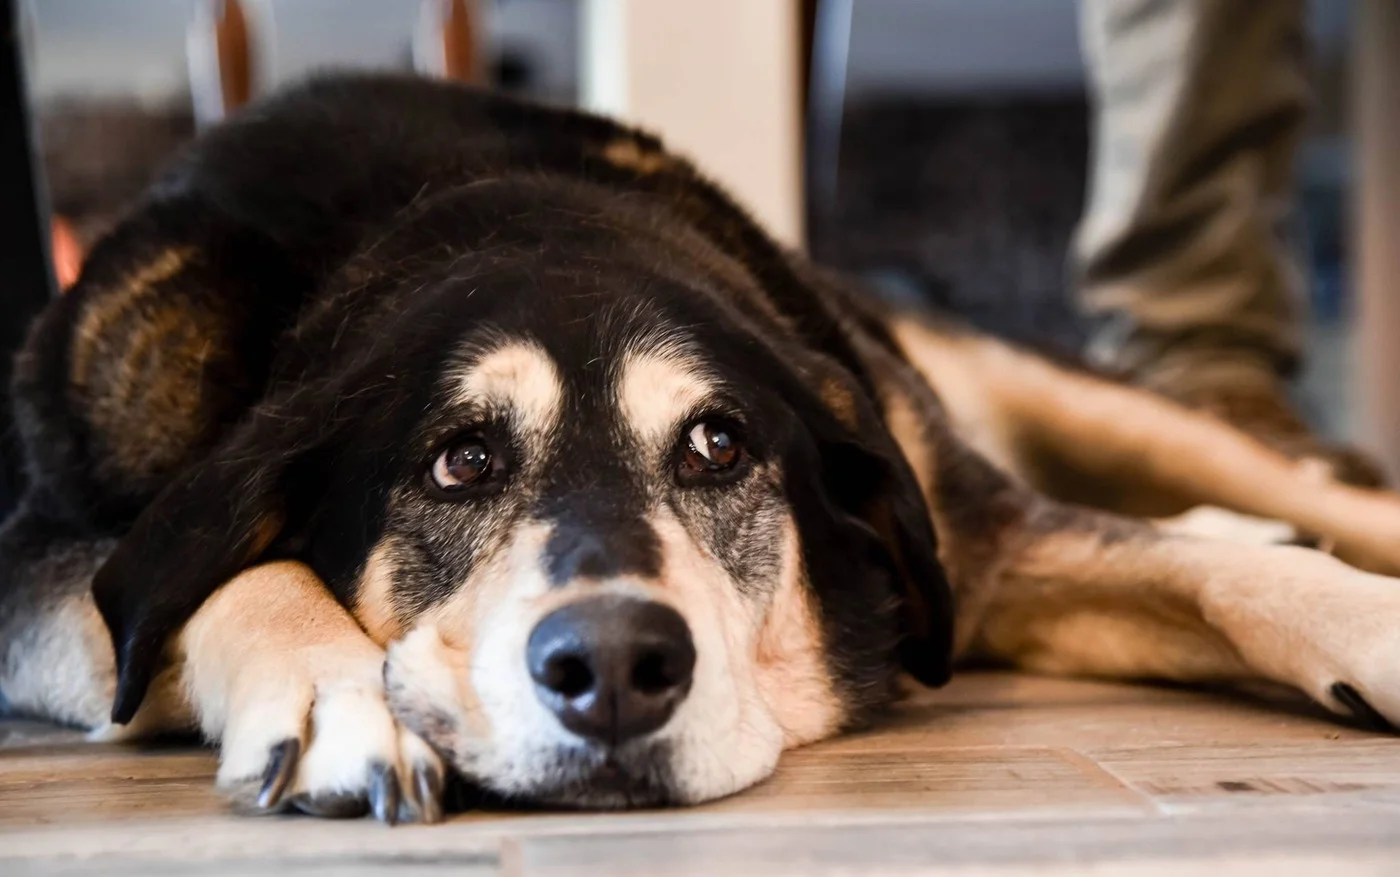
[208,643,444,824]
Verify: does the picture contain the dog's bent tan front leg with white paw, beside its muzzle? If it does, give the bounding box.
[174,562,444,822]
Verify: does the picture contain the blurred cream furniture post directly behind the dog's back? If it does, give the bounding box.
[581,0,804,245]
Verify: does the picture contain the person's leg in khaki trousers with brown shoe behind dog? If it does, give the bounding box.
[1072,0,1375,481]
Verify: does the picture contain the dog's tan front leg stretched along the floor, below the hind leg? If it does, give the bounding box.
[960,504,1400,724]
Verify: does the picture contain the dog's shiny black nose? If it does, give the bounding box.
[525,597,696,745]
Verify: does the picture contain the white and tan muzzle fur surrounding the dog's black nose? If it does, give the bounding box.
[385,516,841,806]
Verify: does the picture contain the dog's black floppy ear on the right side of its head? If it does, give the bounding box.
[787,351,953,685]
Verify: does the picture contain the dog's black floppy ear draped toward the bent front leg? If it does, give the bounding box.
[92,381,344,723]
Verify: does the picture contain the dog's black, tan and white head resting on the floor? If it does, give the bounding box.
[95,179,952,807]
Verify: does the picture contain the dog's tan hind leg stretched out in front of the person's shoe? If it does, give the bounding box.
[896,313,1400,573]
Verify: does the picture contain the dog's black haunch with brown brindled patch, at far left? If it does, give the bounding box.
[10,196,307,531]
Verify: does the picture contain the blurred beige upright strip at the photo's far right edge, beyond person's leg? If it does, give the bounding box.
[1352,0,1400,478]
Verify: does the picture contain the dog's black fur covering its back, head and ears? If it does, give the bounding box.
[0,76,953,721]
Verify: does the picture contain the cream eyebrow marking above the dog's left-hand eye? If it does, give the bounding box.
[456,340,564,433]
